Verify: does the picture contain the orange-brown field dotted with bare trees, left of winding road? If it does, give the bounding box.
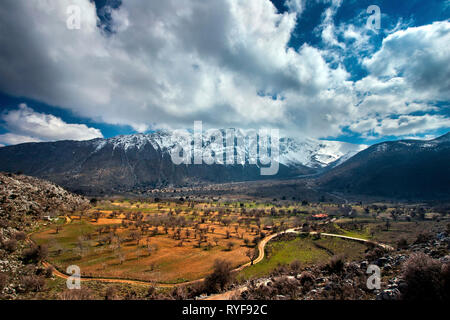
[33,203,266,283]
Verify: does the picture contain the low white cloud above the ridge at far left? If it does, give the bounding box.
[0,104,103,144]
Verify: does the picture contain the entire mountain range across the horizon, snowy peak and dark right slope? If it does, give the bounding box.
[0,130,450,199]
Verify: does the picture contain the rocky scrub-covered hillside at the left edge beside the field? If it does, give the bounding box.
[0,173,89,300]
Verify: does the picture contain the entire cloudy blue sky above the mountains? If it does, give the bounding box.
[0,0,450,146]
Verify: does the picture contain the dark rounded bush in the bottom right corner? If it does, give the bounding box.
[402,253,445,300]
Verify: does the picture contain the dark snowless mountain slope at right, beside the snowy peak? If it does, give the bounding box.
[317,133,450,200]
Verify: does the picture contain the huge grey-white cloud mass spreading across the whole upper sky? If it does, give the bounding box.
[0,0,450,138]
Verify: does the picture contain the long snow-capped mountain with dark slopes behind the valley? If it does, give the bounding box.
[0,129,365,194]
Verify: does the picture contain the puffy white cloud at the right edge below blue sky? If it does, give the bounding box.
[364,21,450,100]
